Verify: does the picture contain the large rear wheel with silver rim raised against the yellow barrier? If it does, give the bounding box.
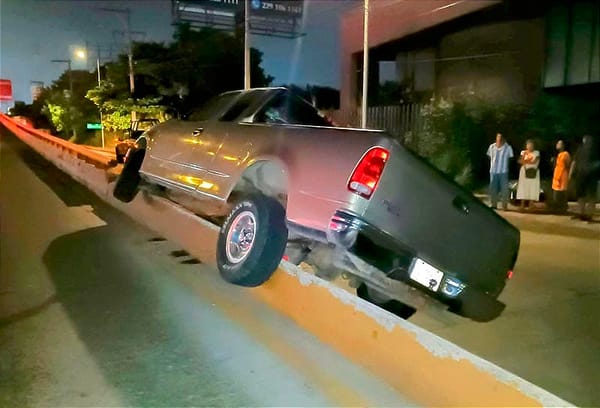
[217,194,288,287]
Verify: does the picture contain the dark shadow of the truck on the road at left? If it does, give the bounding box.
[43,220,248,406]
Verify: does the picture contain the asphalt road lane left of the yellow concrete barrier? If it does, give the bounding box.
[0,129,409,407]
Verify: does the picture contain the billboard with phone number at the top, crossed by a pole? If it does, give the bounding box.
[172,0,304,38]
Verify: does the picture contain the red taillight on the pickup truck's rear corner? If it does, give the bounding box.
[348,147,390,198]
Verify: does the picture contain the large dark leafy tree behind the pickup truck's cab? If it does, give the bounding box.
[88,25,273,129]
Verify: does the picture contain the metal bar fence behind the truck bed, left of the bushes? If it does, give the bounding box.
[332,104,423,141]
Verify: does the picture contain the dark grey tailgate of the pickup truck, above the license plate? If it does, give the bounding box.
[362,143,520,291]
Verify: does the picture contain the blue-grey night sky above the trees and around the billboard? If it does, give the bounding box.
[0,0,360,102]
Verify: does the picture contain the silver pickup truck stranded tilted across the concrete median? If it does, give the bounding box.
[114,88,520,321]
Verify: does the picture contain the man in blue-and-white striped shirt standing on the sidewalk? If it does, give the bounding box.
[487,133,514,210]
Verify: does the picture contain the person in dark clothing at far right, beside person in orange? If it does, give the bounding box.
[569,135,600,221]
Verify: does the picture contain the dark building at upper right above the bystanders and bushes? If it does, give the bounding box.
[341,0,600,110]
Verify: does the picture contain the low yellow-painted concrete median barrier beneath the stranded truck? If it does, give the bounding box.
[0,116,572,407]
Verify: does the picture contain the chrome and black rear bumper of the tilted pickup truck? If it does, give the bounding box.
[327,211,505,321]
